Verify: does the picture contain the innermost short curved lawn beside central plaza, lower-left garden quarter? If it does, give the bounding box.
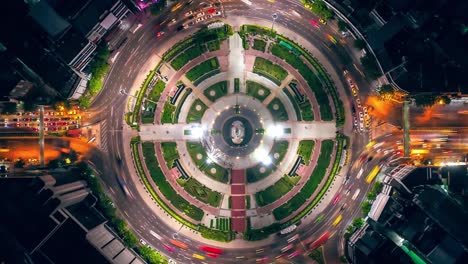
[187,142,229,183]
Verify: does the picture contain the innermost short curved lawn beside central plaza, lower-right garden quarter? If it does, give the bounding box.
[246,141,289,183]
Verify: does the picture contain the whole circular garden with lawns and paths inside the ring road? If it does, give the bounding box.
[129,25,347,242]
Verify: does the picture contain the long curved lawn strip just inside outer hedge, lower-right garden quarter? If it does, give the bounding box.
[273,140,334,221]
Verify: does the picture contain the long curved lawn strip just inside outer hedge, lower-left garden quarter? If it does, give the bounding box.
[141,142,204,221]
